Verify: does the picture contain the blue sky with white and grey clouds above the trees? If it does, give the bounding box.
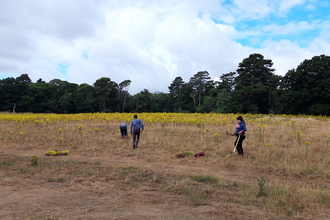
[0,0,330,94]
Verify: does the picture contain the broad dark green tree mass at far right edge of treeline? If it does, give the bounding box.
[278,55,330,115]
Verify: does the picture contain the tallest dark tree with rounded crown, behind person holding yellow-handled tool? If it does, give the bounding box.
[233,53,275,113]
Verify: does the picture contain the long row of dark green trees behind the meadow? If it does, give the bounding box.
[0,53,330,116]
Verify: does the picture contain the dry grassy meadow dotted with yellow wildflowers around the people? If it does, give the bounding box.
[0,113,330,220]
